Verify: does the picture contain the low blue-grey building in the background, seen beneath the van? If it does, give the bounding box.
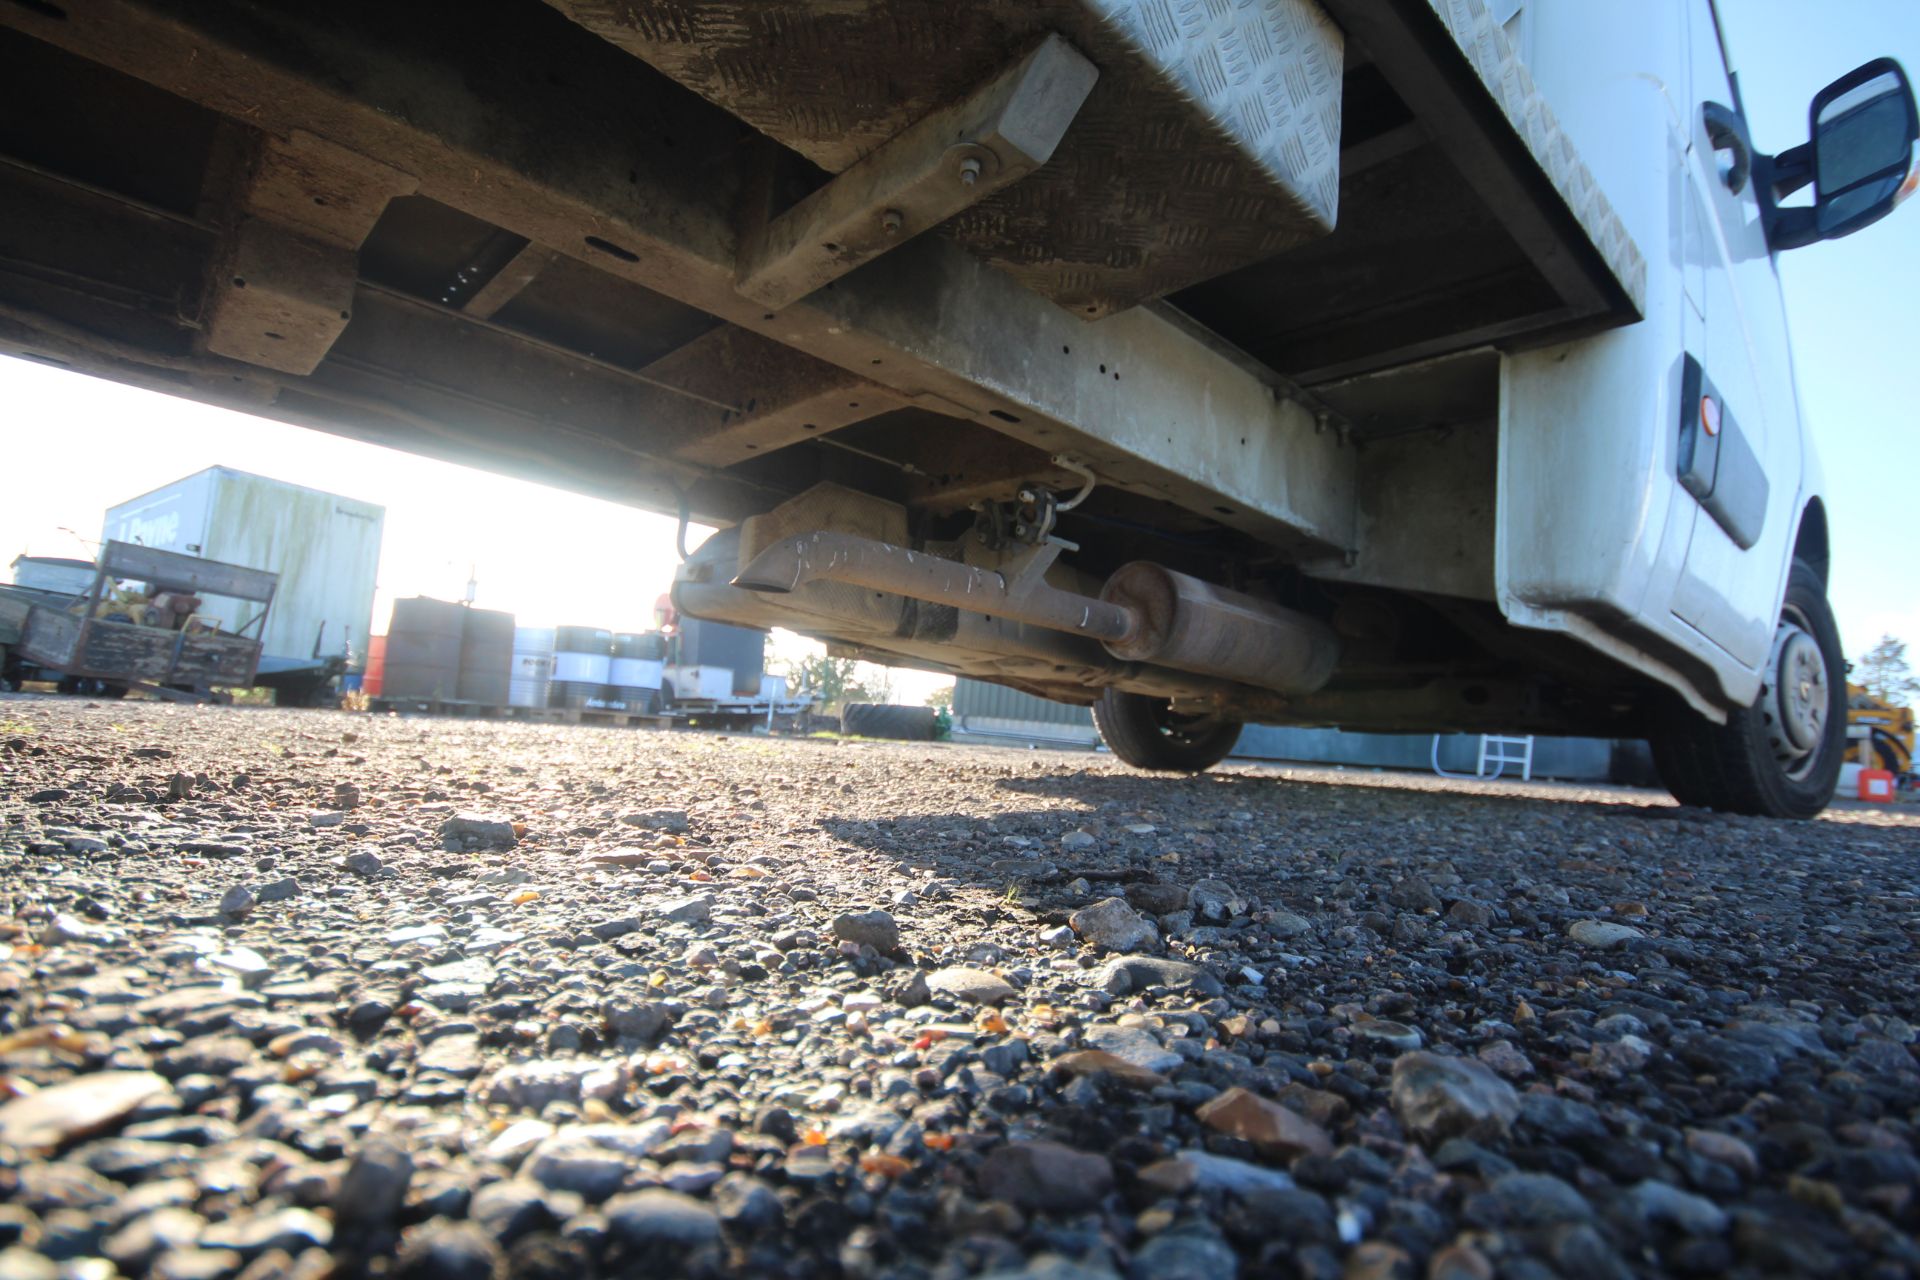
[954,679,1649,781]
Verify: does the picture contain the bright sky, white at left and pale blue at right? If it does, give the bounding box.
[0,0,1920,700]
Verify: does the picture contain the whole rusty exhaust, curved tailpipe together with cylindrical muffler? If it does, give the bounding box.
[733,530,1340,693]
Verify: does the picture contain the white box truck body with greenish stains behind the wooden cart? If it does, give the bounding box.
[106,466,386,706]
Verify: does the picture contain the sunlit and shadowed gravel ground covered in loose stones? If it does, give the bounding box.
[0,697,1920,1280]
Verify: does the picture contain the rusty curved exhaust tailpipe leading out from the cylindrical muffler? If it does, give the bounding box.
[733,530,1133,641]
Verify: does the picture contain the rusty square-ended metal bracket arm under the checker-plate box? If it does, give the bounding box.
[735,35,1100,309]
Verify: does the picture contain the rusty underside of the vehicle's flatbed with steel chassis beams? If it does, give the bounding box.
[0,0,1644,729]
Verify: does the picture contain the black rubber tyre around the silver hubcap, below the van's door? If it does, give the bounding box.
[1649,560,1847,818]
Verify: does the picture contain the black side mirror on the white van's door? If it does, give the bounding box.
[1757,58,1920,251]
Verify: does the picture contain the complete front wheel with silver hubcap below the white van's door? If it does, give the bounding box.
[1651,560,1847,818]
